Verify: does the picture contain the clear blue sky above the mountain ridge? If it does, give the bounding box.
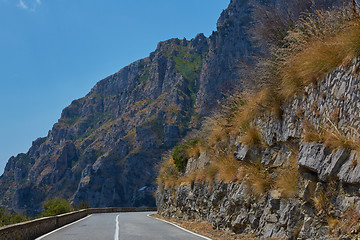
[0,0,230,174]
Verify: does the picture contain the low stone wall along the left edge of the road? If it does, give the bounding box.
[0,207,157,240]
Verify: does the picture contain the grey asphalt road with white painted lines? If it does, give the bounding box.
[37,212,208,240]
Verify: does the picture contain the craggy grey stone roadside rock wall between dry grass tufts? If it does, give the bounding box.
[157,59,360,239]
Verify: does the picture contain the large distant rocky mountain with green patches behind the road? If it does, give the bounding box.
[0,0,254,215]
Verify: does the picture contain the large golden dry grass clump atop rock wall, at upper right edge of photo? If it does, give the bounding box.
[280,17,360,99]
